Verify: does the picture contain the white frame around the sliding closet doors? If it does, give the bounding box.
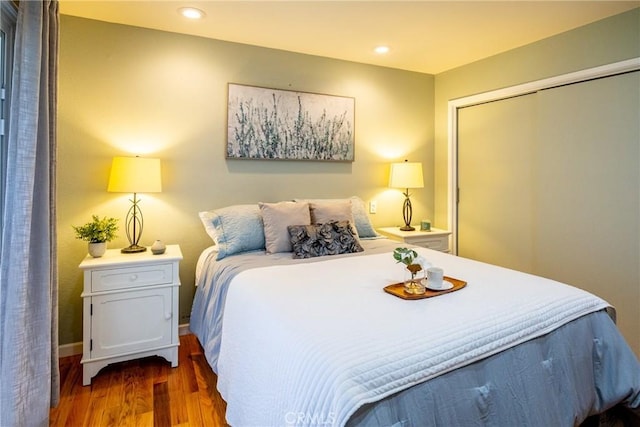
[447,57,640,255]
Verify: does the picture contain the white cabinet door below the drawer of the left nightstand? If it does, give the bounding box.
[90,287,174,359]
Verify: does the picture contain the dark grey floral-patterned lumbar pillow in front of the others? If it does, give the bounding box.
[288,221,364,258]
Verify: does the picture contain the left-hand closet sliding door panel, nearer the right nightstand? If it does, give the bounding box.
[457,95,535,272]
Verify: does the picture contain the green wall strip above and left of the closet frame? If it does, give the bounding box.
[434,8,640,227]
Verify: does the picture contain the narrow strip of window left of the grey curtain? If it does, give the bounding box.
[0,1,17,238]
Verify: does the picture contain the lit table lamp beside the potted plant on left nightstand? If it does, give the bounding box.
[107,157,162,253]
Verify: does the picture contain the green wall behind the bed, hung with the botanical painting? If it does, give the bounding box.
[58,16,437,344]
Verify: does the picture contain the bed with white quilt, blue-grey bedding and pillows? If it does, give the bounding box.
[190,198,640,427]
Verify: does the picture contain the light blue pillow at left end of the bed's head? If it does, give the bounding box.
[199,205,264,260]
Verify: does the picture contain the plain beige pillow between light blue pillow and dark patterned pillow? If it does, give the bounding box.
[258,202,311,254]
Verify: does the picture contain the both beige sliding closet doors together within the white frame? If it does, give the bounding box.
[457,72,640,353]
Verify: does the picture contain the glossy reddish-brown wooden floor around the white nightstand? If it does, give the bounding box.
[49,335,227,427]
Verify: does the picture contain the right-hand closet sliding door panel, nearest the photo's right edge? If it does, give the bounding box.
[534,72,640,349]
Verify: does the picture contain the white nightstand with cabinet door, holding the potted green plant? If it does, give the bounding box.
[80,245,182,385]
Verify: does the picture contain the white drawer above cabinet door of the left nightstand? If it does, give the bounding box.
[91,264,173,292]
